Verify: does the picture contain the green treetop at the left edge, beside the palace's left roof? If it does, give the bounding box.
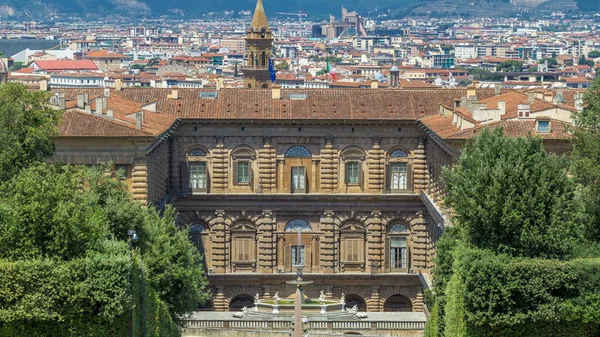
[0,83,61,183]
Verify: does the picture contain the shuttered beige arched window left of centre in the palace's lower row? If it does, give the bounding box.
[231,220,256,272]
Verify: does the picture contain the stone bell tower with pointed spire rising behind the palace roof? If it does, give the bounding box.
[244,0,273,89]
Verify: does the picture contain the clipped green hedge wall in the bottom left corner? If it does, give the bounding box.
[0,248,179,337]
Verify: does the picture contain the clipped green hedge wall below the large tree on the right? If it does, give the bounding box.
[444,248,600,337]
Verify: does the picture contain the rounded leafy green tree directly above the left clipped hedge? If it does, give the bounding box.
[0,164,108,260]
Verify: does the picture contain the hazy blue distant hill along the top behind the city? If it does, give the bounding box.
[0,0,600,19]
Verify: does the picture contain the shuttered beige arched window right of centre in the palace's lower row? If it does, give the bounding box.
[339,221,367,272]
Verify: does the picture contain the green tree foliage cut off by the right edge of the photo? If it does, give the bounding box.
[571,76,600,242]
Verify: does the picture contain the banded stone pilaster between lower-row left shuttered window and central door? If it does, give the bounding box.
[257,210,277,274]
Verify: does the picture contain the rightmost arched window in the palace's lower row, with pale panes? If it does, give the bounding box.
[386,223,410,271]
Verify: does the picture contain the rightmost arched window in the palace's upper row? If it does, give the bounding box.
[385,149,413,193]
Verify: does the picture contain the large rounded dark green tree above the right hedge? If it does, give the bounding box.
[443,128,581,258]
